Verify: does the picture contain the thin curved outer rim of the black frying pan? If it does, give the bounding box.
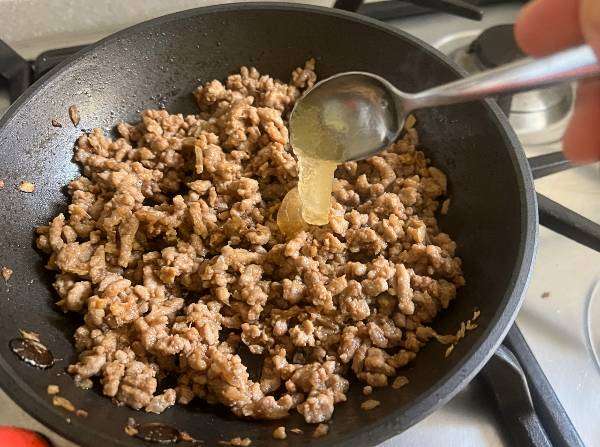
[0,2,538,446]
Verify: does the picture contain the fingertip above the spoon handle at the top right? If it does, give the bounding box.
[515,0,584,56]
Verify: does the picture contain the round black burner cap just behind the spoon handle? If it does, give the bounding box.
[469,25,525,68]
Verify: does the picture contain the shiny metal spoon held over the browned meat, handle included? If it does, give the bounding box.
[290,45,600,161]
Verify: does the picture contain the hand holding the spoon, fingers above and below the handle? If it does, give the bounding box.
[515,0,600,163]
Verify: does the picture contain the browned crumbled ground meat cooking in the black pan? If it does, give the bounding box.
[37,60,464,426]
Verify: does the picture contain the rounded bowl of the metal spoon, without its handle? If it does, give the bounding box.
[290,71,405,161]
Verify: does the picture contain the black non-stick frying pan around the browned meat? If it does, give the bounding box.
[0,3,537,446]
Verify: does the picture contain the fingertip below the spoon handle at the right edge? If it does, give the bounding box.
[563,80,600,163]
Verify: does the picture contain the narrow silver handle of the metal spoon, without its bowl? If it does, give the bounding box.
[407,45,600,110]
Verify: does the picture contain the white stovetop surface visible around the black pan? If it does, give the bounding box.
[0,0,600,447]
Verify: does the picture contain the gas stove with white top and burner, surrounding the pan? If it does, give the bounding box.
[0,0,600,447]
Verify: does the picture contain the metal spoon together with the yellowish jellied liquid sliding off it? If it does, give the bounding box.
[289,45,600,230]
